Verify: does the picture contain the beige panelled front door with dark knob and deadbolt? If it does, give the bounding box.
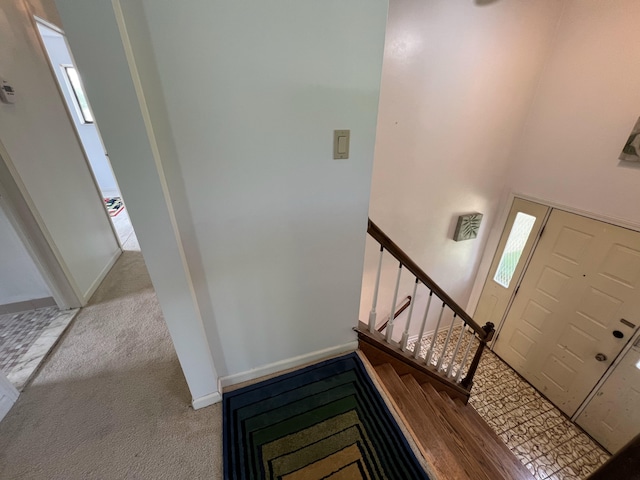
[494,210,640,416]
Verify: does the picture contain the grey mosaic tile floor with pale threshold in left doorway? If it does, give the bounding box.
[0,307,78,390]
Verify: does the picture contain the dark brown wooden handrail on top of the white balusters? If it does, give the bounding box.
[367,219,494,343]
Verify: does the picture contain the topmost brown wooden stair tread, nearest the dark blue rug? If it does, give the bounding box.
[374,363,470,480]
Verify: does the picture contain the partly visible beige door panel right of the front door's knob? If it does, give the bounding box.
[576,339,640,453]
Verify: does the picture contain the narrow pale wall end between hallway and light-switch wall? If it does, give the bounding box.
[56,0,221,408]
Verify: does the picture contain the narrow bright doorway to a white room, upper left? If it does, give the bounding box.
[35,17,140,250]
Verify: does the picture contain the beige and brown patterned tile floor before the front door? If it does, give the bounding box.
[410,327,610,480]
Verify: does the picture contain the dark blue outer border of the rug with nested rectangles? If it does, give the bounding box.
[222,352,429,480]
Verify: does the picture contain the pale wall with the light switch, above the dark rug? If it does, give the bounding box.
[138,0,387,376]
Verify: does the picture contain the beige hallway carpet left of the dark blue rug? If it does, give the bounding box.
[0,251,222,479]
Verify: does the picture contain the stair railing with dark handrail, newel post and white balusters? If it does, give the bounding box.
[367,219,495,391]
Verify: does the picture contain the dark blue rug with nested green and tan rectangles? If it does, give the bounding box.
[223,353,429,480]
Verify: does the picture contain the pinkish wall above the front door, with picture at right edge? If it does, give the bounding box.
[470,0,640,314]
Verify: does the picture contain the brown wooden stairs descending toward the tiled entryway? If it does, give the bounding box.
[374,363,534,480]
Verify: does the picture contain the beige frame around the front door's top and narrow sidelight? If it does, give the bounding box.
[468,191,640,352]
